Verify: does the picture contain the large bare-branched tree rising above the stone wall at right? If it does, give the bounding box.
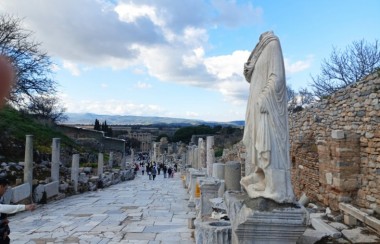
[311,39,380,99]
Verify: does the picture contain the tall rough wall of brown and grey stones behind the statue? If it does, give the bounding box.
[289,72,380,210]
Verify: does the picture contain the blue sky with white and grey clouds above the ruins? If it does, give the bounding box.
[0,0,380,122]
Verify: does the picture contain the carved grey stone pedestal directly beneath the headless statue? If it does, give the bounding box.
[224,191,308,244]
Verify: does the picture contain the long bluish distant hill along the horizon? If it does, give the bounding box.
[64,113,244,126]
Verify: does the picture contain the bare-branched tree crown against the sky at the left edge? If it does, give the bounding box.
[0,14,56,108]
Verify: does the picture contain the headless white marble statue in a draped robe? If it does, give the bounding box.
[240,32,295,203]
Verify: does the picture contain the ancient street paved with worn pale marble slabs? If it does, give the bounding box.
[9,171,195,244]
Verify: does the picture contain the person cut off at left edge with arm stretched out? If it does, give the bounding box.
[0,176,36,244]
